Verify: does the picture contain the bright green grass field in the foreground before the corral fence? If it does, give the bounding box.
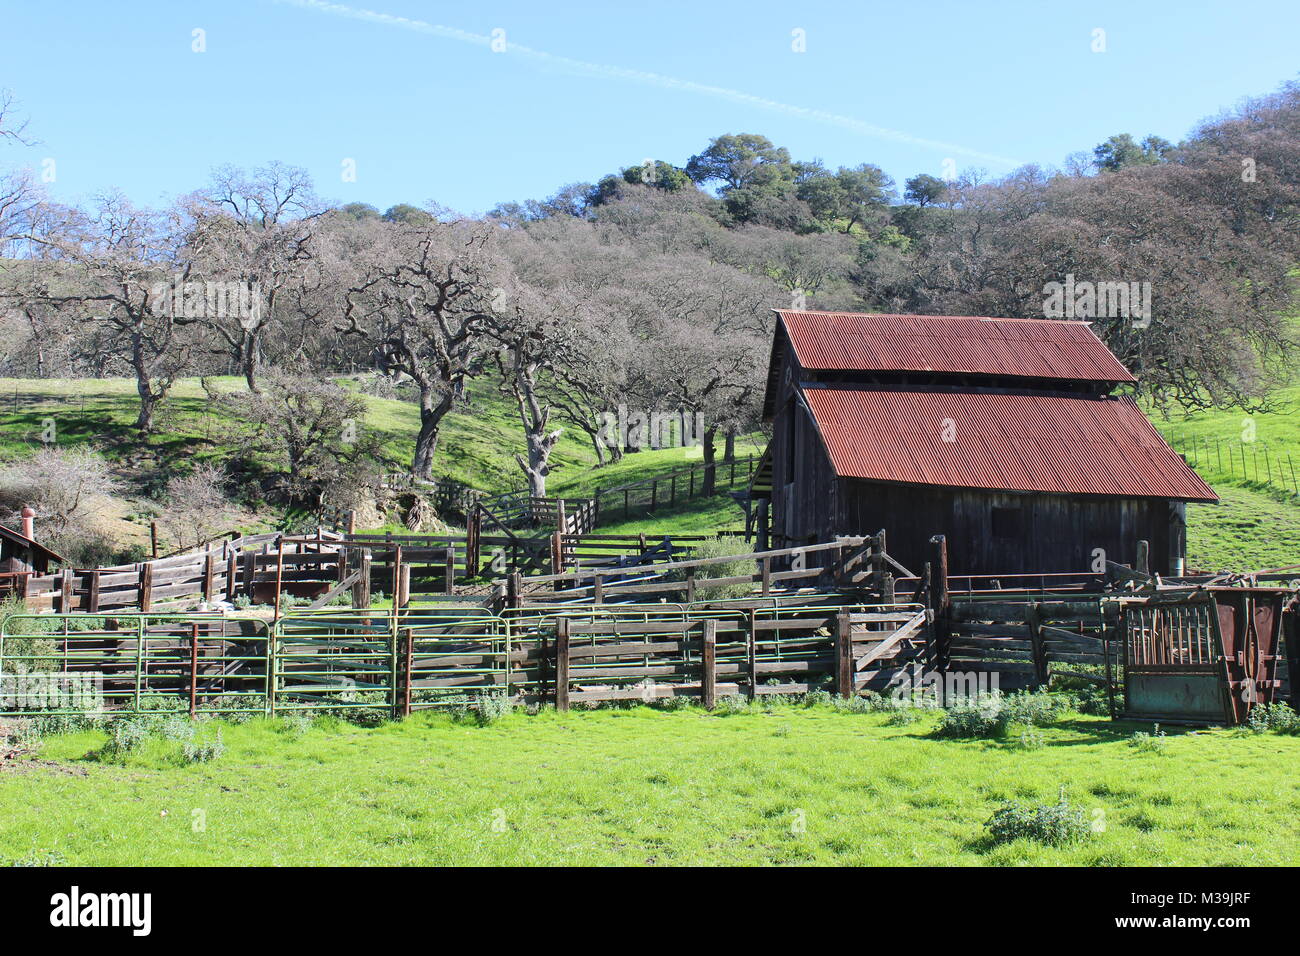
[0,705,1300,866]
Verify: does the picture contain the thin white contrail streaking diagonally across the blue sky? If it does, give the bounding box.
[274,0,1021,168]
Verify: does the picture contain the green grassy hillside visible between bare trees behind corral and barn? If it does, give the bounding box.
[0,377,1300,570]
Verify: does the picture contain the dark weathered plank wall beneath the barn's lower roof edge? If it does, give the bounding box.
[824,479,1171,574]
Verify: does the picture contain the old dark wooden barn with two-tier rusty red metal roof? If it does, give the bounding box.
[753,310,1218,575]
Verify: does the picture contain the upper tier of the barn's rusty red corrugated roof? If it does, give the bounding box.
[775,308,1136,382]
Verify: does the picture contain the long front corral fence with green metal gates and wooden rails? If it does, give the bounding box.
[0,600,932,715]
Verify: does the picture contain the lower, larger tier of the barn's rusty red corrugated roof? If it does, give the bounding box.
[803,388,1218,501]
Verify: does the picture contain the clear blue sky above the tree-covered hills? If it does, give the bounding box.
[0,0,1300,213]
